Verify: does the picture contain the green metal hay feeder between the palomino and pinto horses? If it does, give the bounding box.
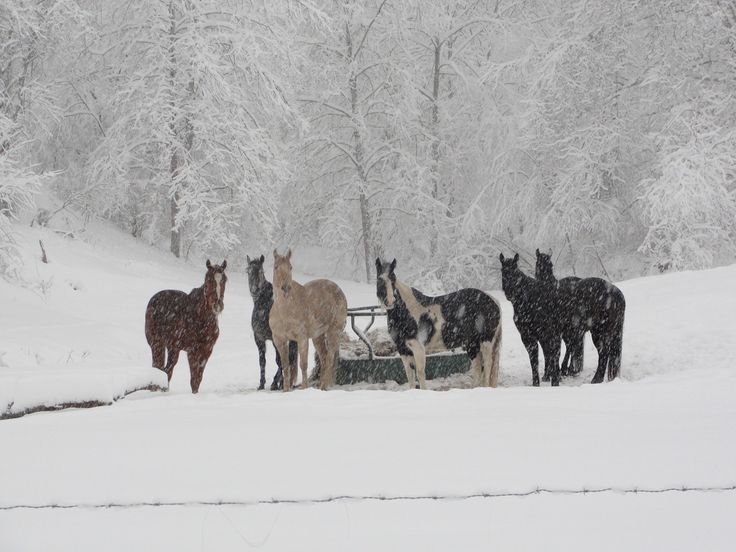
[336,306,470,385]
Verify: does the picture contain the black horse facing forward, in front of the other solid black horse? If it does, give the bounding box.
[499,253,561,387]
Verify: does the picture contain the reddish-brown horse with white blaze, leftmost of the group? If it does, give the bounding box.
[146,259,227,393]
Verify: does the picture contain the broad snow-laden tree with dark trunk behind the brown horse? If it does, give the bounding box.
[88,0,302,256]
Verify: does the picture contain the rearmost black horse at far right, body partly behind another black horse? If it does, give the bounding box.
[537,251,626,383]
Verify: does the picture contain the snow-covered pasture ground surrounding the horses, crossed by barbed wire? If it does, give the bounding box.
[0,222,736,552]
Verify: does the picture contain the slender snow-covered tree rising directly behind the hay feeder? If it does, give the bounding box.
[291,0,420,279]
